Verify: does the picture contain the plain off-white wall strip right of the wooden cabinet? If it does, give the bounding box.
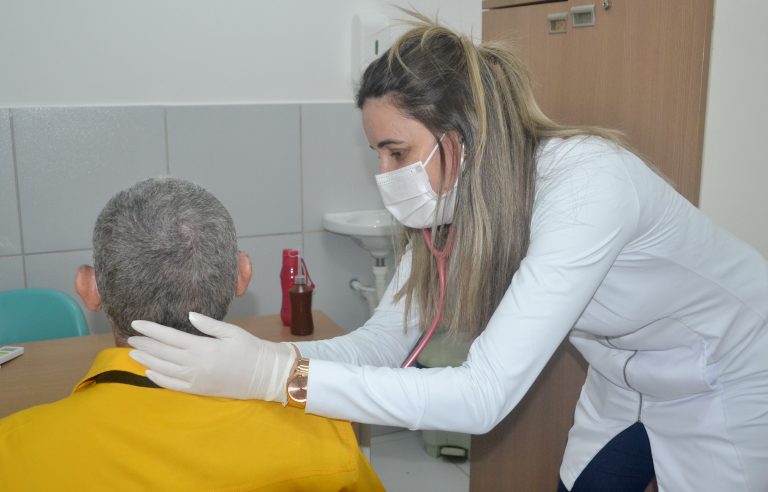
[700,0,768,257]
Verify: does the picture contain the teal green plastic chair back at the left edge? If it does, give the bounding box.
[0,289,88,345]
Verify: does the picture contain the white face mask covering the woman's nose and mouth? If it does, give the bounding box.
[376,140,464,229]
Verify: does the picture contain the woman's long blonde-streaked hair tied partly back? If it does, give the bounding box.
[356,11,620,336]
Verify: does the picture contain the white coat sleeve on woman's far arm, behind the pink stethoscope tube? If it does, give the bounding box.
[295,251,421,367]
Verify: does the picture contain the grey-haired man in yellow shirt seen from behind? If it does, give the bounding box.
[0,178,383,491]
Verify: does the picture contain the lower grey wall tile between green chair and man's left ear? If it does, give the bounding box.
[25,250,111,333]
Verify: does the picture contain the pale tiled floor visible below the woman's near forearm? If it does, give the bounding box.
[371,428,469,492]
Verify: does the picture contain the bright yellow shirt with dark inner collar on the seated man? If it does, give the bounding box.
[0,348,384,492]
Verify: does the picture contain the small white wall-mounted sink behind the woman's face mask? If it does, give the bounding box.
[323,210,397,258]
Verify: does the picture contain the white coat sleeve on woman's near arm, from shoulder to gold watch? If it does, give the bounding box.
[307,147,639,434]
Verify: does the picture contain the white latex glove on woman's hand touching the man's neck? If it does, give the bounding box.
[128,313,296,405]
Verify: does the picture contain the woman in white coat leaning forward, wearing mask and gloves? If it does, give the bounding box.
[129,19,768,492]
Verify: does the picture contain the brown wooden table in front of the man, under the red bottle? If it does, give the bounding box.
[0,310,346,418]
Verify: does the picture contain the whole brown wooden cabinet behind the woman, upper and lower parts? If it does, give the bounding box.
[470,0,713,491]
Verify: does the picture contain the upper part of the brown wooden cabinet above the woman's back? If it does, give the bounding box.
[483,0,713,204]
